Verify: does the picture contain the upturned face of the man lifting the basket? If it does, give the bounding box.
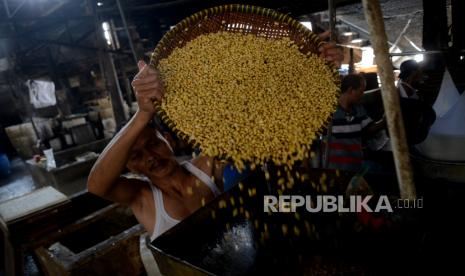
[126,128,177,178]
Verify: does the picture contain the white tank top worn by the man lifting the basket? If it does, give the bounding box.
[150,161,221,241]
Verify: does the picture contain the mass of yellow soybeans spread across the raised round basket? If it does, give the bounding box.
[157,32,338,168]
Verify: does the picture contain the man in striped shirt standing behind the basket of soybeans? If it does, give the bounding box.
[327,74,385,171]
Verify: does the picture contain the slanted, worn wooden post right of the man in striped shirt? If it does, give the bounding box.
[362,0,416,199]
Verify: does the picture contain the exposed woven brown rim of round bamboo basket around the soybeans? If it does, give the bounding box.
[150,4,340,158]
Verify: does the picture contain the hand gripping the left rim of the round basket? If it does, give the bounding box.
[131,61,164,116]
